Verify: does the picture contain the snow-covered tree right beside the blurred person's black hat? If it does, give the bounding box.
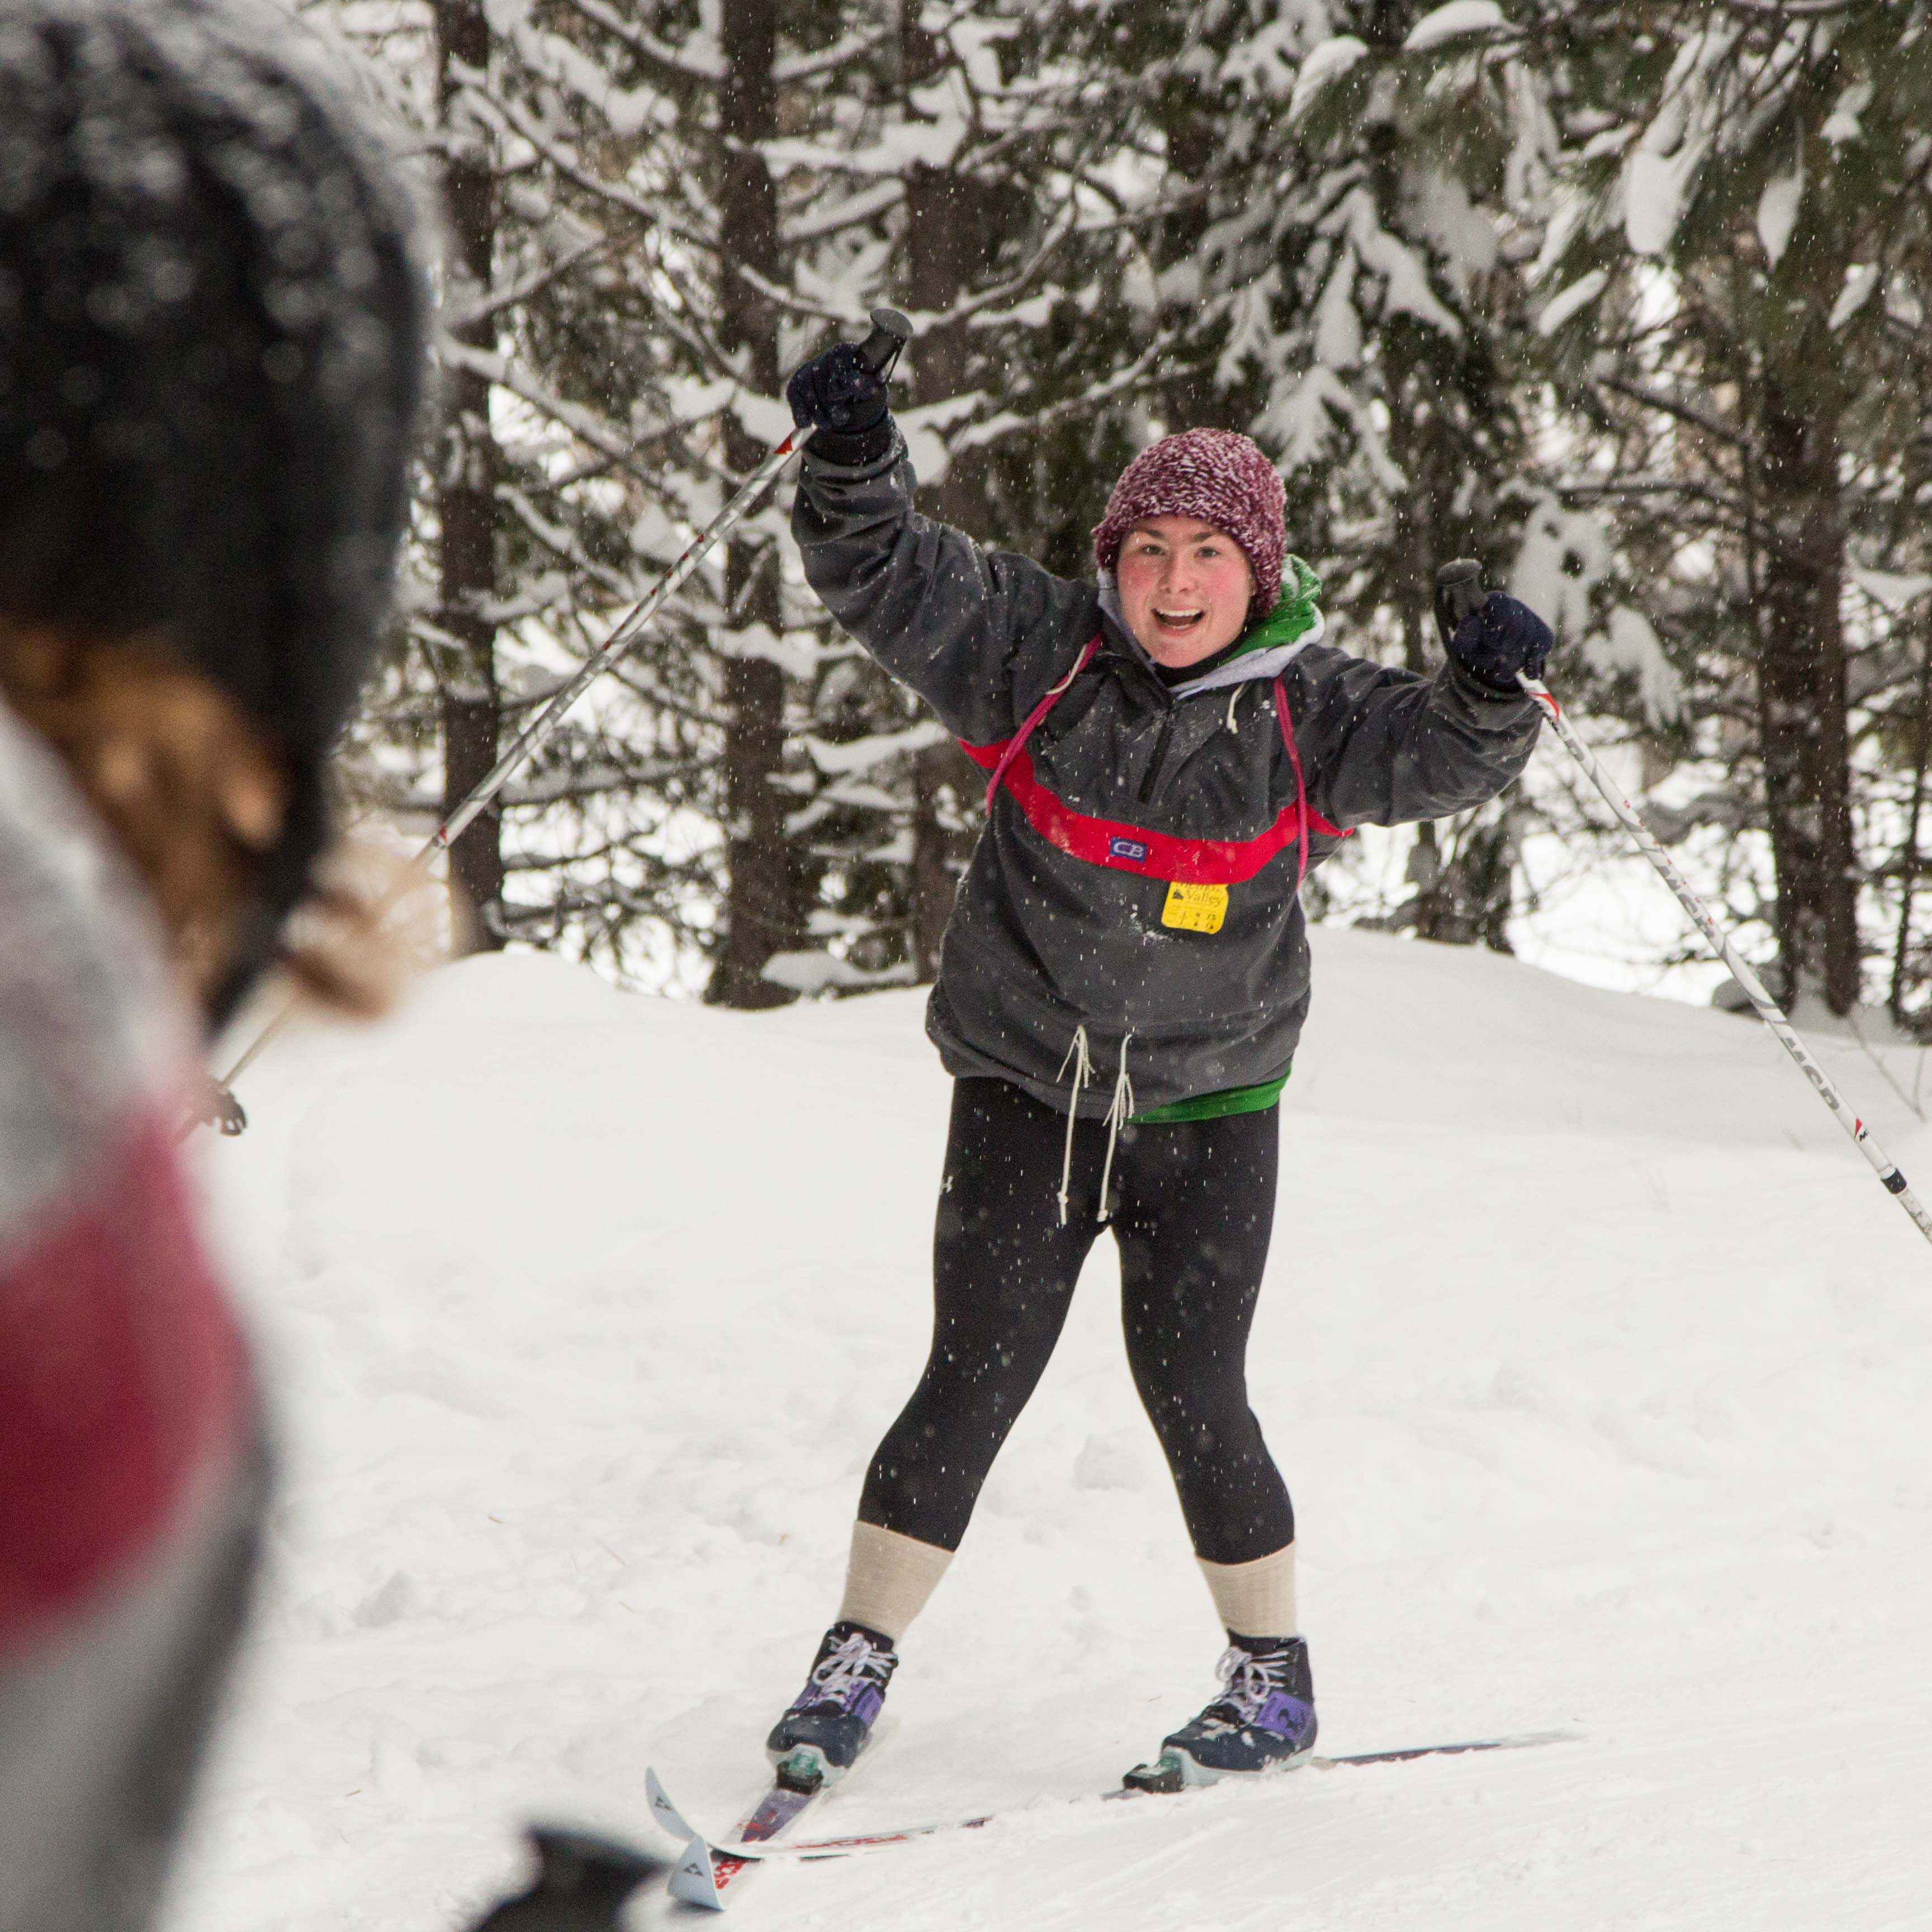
[307,0,723,974]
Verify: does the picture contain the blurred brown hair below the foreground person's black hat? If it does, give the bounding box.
[0,618,402,1016]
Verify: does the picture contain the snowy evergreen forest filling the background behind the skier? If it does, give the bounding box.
[297,0,1932,1039]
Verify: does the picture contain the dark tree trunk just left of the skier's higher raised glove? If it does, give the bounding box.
[705,0,804,1008]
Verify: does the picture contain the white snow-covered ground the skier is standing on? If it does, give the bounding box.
[176,931,1932,1932]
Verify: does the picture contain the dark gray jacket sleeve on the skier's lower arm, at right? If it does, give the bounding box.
[1292,643,1542,827]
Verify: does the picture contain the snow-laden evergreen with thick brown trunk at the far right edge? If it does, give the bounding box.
[1518,0,1932,1010]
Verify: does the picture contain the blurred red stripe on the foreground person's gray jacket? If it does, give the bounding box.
[0,1117,245,1652]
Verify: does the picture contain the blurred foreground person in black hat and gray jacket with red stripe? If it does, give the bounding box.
[0,0,425,1932]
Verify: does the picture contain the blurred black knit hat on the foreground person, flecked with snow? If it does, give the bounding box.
[0,0,427,1027]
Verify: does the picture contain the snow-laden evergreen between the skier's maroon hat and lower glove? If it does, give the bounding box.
[1097,0,1546,949]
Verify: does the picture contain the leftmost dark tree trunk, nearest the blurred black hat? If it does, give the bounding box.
[435,0,504,953]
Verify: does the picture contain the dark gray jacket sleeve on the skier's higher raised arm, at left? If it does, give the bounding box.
[792,439,1097,744]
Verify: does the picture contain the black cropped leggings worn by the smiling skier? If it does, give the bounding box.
[858,1080,1295,1563]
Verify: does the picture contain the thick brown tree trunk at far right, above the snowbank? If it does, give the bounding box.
[1758,369,1859,1012]
